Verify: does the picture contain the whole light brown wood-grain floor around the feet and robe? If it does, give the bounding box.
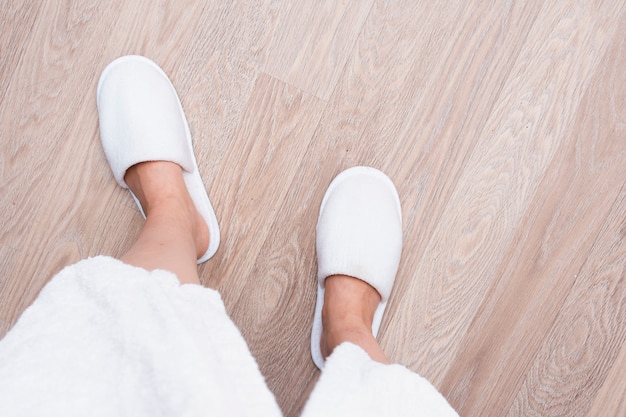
[0,0,626,417]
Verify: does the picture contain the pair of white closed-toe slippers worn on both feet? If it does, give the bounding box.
[97,56,402,369]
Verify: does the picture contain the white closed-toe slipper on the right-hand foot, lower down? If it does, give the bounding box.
[311,167,402,369]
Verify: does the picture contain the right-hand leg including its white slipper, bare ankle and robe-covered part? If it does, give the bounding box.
[302,167,457,417]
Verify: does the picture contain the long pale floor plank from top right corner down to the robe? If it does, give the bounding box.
[385,2,621,394]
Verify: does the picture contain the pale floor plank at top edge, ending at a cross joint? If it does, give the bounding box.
[264,0,373,100]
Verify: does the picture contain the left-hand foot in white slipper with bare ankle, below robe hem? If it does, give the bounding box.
[96,52,220,283]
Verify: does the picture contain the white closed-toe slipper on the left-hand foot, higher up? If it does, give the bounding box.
[97,55,220,263]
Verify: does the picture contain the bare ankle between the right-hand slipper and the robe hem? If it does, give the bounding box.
[320,275,390,363]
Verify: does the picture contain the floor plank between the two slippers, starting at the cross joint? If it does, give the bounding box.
[203,74,323,292]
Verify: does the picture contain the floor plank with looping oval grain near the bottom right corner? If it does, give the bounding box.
[508,185,626,416]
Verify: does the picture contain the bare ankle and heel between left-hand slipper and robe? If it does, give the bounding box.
[121,161,209,284]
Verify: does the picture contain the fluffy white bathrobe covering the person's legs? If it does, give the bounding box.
[0,256,456,417]
